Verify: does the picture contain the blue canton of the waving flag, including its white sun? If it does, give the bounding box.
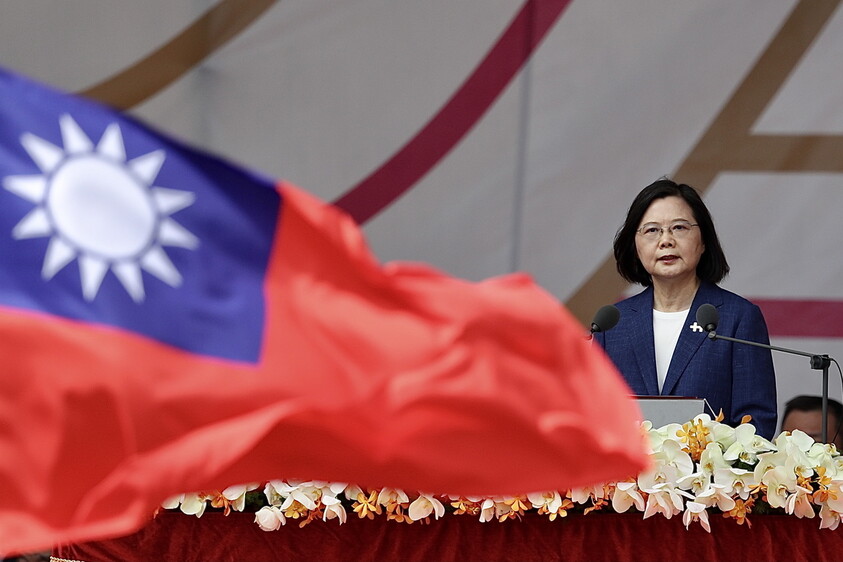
[0,70,281,363]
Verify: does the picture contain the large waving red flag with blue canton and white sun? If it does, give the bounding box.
[0,66,646,553]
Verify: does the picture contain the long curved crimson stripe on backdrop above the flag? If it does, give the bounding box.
[334,0,570,224]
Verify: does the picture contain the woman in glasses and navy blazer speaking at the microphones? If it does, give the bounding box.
[596,179,777,439]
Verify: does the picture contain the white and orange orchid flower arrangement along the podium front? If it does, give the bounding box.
[162,414,843,533]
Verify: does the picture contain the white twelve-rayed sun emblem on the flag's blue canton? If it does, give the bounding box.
[3,111,199,303]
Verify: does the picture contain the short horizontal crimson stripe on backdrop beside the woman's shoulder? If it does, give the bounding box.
[750,298,843,338]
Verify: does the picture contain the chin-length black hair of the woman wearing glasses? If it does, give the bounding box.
[613,178,729,287]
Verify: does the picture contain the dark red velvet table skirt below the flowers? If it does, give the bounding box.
[53,512,843,562]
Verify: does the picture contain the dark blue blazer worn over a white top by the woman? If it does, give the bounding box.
[595,283,778,439]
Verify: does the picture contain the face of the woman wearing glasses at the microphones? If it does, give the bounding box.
[635,195,705,285]
